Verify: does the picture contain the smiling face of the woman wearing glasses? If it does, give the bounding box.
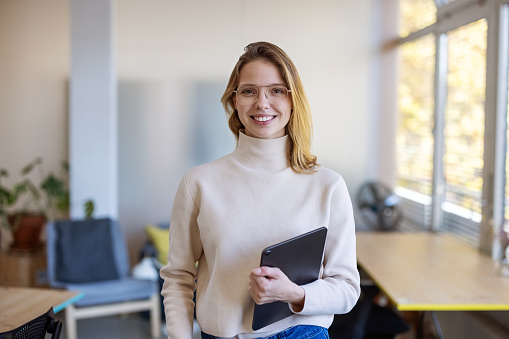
[234,60,292,139]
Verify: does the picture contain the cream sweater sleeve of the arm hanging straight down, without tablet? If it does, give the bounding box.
[160,176,202,339]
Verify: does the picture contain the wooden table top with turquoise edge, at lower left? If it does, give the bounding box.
[0,286,83,332]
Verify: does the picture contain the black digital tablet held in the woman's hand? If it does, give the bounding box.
[252,227,327,331]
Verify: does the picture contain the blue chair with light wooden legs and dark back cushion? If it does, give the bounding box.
[46,219,161,339]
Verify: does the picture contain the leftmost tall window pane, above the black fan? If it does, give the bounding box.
[396,35,435,196]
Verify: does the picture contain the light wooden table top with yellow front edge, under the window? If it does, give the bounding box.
[356,232,509,311]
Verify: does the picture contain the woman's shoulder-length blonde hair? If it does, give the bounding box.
[221,42,319,173]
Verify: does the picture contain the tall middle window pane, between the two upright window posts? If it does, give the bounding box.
[442,19,487,245]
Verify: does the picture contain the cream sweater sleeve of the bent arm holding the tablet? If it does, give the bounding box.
[292,177,360,315]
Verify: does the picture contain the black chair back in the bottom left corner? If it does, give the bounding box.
[0,307,62,339]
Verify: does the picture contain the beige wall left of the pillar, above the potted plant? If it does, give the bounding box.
[0,0,70,248]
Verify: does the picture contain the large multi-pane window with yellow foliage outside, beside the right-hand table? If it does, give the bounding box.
[395,0,509,252]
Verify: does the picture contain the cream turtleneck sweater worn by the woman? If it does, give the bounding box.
[161,132,360,339]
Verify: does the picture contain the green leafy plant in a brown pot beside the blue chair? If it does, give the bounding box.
[0,158,69,250]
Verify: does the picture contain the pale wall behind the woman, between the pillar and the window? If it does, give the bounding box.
[117,0,377,258]
